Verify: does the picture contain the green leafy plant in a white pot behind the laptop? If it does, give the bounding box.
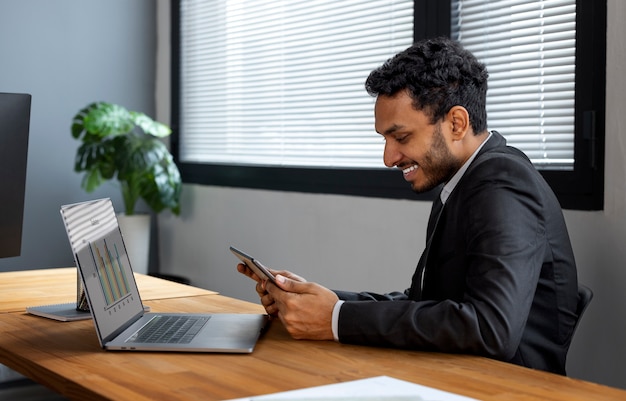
[71,102,182,273]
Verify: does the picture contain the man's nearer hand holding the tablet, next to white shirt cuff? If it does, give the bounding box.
[262,272,339,340]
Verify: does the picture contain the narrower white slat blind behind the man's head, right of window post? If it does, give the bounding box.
[452,0,576,170]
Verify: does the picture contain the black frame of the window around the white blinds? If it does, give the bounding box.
[170,0,607,210]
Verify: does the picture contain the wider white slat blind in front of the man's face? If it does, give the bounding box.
[179,0,413,167]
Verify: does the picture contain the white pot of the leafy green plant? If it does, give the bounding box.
[117,213,151,274]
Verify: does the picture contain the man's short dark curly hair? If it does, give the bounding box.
[365,37,489,134]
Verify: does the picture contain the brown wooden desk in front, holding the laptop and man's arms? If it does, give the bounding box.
[0,273,626,401]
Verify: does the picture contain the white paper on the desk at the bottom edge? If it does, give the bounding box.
[232,376,476,401]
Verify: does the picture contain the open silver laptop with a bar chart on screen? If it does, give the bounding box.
[61,198,268,353]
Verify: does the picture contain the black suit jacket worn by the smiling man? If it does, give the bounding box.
[336,132,578,374]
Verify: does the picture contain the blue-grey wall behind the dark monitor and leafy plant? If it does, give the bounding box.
[0,0,156,271]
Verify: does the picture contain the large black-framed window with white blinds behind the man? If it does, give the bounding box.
[172,0,606,209]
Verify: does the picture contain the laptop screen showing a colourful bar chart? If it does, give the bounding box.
[61,199,143,343]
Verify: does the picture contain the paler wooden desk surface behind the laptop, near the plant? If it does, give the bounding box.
[0,267,216,313]
